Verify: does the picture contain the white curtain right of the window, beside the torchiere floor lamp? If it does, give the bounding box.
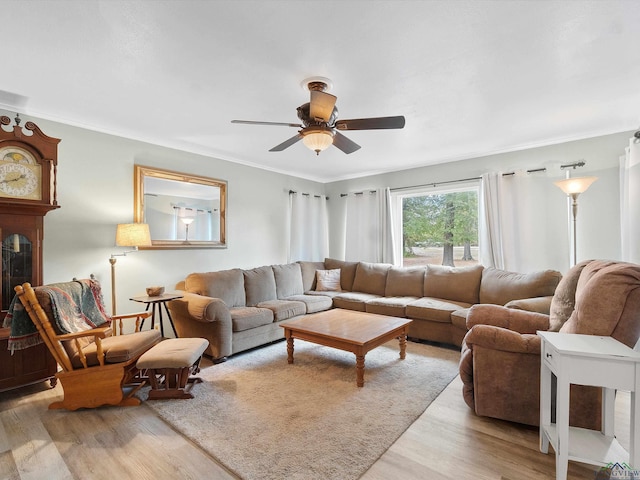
[478,172,569,272]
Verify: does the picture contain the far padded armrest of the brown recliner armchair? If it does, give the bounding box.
[467,304,549,334]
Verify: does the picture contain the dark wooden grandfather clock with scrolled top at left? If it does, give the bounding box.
[0,115,60,391]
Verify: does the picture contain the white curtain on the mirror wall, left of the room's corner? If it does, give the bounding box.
[289,193,329,262]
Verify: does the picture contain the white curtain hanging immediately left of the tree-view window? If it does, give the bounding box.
[345,188,395,264]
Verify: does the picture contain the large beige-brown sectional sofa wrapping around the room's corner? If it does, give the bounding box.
[167,258,561,359]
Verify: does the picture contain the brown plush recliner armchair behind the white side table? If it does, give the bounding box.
[460,260,640,430]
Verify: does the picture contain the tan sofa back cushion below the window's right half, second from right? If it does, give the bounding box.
[424,265,484,303]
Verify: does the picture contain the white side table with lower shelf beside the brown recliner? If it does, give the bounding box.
[538,332,640,480]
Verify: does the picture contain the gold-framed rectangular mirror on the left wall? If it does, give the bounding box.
[133,165,227,249]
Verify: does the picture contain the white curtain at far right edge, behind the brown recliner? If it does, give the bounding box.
[620,138,640,263]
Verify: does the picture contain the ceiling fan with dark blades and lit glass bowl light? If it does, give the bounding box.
[231,77,404,155]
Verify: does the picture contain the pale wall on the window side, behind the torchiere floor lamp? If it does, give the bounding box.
[326,132,632,272]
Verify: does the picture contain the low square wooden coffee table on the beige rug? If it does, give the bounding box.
[280,308,412,387]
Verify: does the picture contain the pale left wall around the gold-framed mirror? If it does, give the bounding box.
[0,110,324,313]
